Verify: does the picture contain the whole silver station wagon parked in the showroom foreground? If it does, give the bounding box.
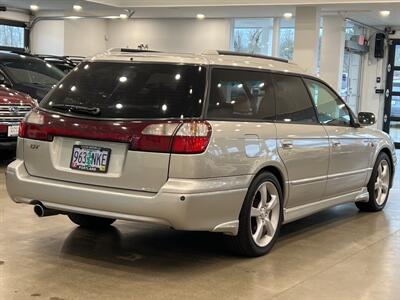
[6,49,396,256]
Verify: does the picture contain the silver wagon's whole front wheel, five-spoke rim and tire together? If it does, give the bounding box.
[356,152,392,212]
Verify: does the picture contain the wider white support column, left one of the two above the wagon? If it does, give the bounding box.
[293,6,320,74]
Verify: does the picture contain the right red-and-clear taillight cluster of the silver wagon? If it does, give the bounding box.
[131,121,211,154]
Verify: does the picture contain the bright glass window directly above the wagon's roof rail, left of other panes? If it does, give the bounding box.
[232,18,274,55]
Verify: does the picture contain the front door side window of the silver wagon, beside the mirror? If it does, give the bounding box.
[305,79,351,126]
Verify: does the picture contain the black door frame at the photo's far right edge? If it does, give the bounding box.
[383,39,400,149]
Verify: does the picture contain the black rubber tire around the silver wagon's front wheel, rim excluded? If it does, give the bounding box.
[356,152,392,212]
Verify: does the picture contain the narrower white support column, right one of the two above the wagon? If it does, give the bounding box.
[320,16,345,91]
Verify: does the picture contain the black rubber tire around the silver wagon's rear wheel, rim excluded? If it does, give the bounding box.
[230,172,283,257]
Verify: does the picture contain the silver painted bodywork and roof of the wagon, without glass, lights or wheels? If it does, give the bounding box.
[6,50,396,234]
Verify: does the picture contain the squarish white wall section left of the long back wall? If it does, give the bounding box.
[64,19,107,56]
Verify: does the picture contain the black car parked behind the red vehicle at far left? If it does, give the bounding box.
[0,51,65,101]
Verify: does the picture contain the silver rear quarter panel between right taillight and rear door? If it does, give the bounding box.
[169,121,286,198]
